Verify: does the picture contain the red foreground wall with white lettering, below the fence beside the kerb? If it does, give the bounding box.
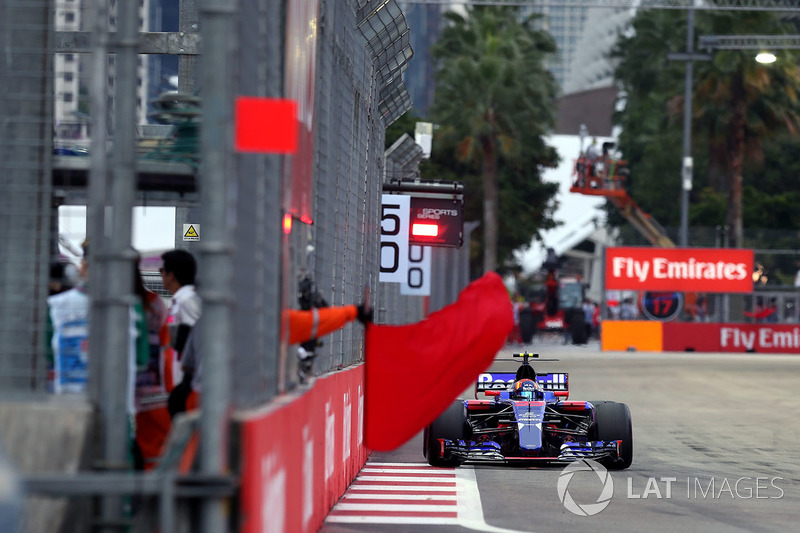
[236,364,369,533]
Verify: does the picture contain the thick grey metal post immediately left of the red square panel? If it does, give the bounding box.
[197,0,236,533]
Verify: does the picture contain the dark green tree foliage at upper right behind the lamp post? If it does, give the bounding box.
[612,10,800,246]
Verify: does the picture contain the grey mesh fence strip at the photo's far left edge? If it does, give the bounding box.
[0,0,57,391]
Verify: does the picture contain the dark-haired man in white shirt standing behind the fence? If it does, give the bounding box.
[160,249,202,392]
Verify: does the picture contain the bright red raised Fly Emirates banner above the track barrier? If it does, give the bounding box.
[606,247,753,292]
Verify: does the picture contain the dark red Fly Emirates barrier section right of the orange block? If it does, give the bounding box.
[663,322,800,353]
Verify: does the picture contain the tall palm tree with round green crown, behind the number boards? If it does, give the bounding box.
[431,7,556,272]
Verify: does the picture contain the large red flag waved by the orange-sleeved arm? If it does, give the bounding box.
[364,272,514,451]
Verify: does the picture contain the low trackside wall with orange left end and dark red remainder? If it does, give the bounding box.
[601,320,800,354]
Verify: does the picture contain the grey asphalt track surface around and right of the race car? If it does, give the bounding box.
[321,343,800,533]
